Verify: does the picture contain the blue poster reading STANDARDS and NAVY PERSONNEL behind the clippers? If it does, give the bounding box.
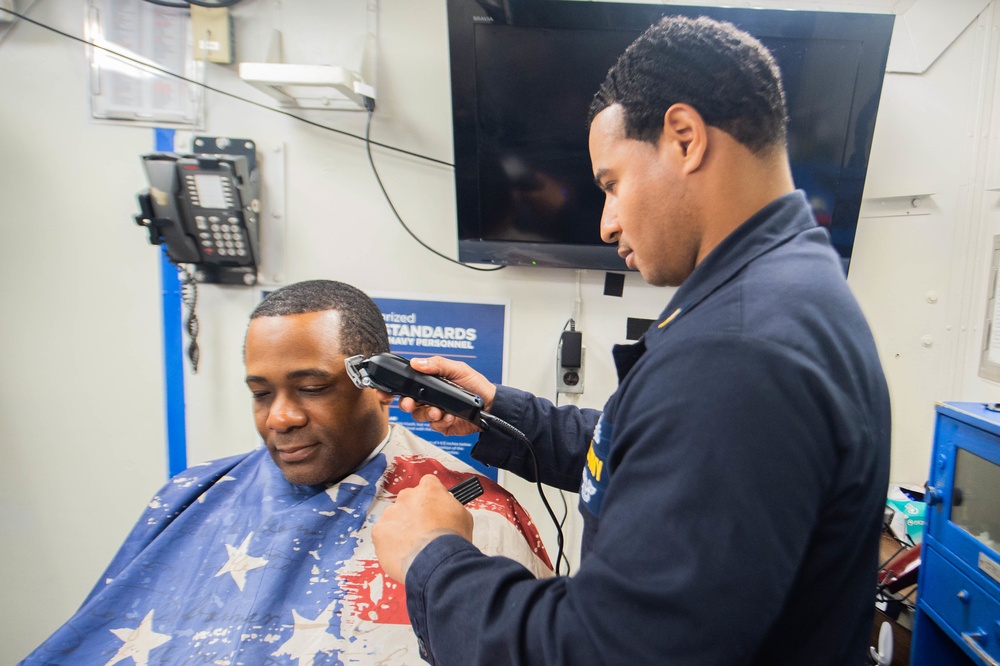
[373,297,508,481]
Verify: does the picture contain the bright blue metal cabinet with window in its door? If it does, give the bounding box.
[910,402,1000,666]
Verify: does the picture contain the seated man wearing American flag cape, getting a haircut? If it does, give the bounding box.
[23,280,551,665]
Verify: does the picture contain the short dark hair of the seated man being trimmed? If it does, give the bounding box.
[250,280,389,357]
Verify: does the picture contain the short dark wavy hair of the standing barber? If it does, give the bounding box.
[590,16,788,153]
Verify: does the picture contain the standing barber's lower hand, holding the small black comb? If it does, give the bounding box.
[372,474,473,583]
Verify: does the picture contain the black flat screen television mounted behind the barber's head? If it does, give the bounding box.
[448,0,894,271]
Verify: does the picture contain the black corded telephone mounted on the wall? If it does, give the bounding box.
[135,137,260,285]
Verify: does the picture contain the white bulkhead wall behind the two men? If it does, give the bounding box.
[0,0,1000,663]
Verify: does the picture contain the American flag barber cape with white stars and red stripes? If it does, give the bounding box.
[22,425,551,666]
